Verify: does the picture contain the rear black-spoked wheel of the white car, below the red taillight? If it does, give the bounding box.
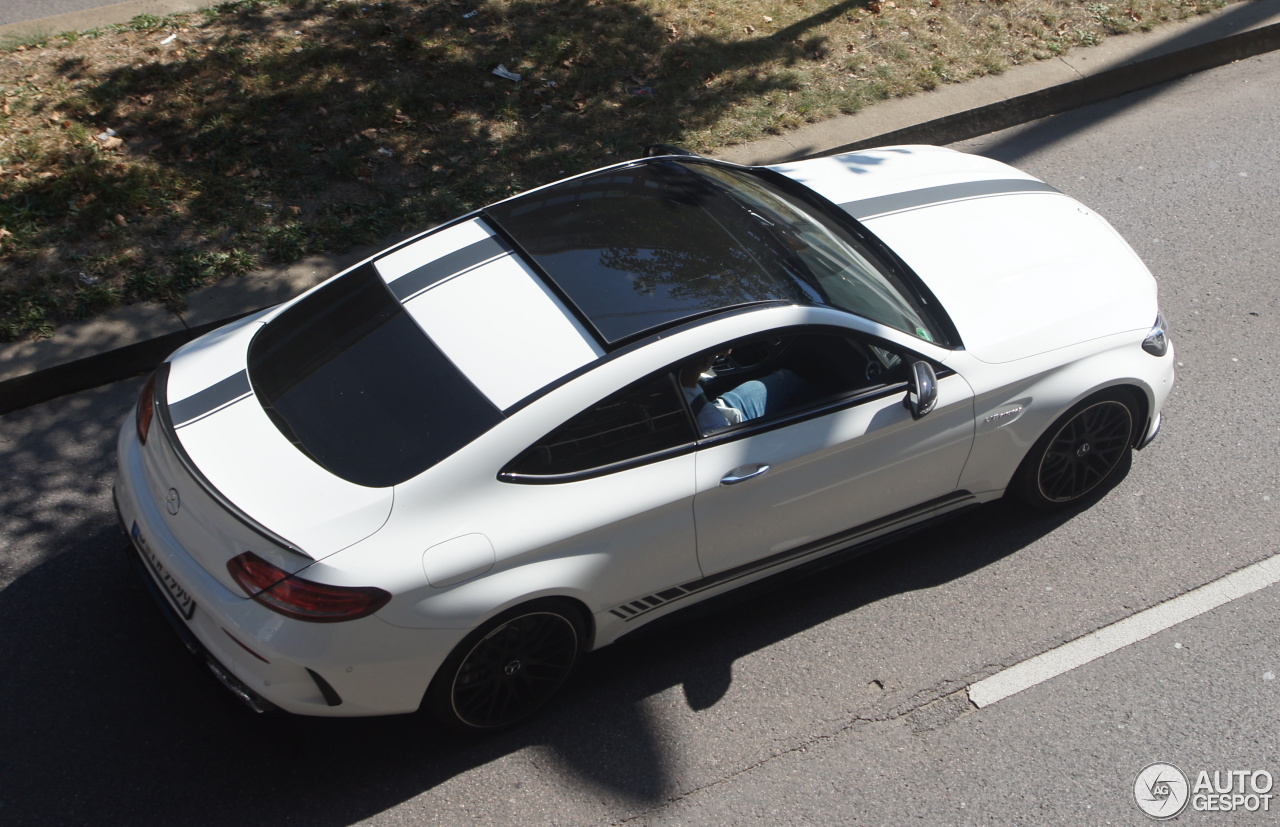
[425,600,585,732]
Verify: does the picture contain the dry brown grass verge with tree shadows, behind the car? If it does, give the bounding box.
[0,0,1224,339]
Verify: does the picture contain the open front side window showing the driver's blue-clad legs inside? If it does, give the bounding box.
[677,330,909,435]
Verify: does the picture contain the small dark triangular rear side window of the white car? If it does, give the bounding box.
[503,373,695,476]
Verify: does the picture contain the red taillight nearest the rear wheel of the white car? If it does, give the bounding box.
[227,552,392,623]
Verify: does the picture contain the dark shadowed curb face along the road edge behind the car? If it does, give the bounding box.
[0,4,1280,414]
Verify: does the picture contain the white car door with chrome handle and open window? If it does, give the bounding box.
[694,332,974,576]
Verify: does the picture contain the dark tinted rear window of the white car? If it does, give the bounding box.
[248,265,502,488]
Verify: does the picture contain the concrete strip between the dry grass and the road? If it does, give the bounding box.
[0,0,1280,414]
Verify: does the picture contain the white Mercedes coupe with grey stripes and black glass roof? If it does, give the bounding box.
[115,146,1174,730]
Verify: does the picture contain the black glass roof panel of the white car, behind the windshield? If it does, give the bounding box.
[483,157,806,349]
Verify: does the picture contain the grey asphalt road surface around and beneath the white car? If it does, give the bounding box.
[0,48,1280,827]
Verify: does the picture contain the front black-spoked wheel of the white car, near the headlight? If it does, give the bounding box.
[1011,389,1138,511]
